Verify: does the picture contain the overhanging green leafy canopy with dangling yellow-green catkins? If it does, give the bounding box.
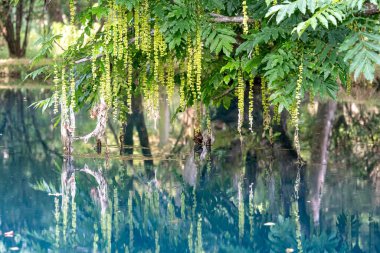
[33,0,380,141]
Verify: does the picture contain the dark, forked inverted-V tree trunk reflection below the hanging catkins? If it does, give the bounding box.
[124,95,153,166]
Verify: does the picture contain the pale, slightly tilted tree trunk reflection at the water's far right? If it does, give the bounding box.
[309,101,337,225]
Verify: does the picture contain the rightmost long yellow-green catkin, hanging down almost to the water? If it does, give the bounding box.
[291,60,303,155]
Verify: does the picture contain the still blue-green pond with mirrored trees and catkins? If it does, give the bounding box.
[0,87,380,252]
